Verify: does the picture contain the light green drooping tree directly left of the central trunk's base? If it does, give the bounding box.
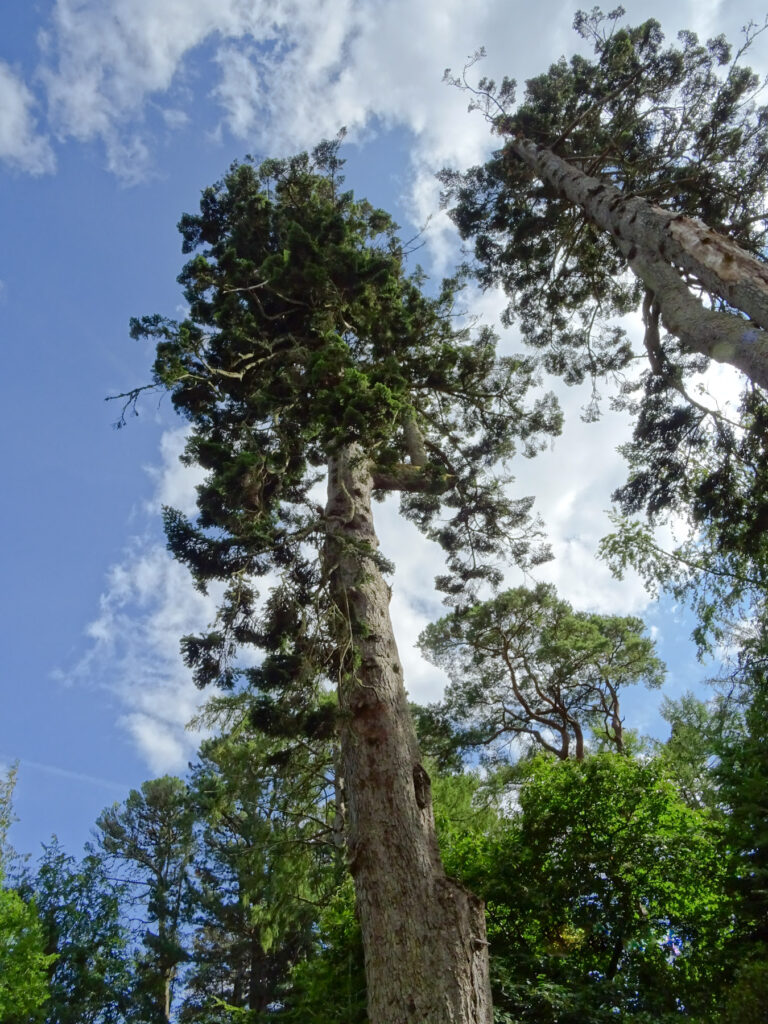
[179,730,338,1022]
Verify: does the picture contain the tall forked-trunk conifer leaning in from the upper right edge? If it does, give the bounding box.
[442,7,768,588]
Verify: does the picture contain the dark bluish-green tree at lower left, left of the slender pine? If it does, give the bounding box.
[31,838,134,1024]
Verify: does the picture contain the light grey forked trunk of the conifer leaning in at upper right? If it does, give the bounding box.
[506,137,768,388]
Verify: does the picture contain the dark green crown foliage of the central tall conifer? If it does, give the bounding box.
[132,143,560,732]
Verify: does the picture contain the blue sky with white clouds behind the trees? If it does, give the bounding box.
[0,0,765,853]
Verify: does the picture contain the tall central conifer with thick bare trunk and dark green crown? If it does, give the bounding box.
[128,143,559,1024]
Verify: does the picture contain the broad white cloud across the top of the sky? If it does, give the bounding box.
[27,0,760,190]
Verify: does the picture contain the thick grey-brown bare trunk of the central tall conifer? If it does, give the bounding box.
[326,445,493,1024]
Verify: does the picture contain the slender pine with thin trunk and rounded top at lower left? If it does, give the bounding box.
[96,775,195,1024]
